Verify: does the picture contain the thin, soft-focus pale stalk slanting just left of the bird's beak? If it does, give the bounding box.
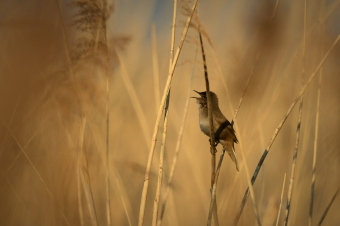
[157,36,197,226]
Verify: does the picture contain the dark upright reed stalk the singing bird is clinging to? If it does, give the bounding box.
[199,32,219,226]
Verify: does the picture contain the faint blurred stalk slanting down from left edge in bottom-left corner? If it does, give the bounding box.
[1,118,70,225]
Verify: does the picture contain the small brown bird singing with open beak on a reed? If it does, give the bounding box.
[192,90,239,171]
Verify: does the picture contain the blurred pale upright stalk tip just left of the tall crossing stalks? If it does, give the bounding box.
[152,24,161,112]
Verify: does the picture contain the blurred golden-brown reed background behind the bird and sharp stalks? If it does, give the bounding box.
[0,0,340,226]
